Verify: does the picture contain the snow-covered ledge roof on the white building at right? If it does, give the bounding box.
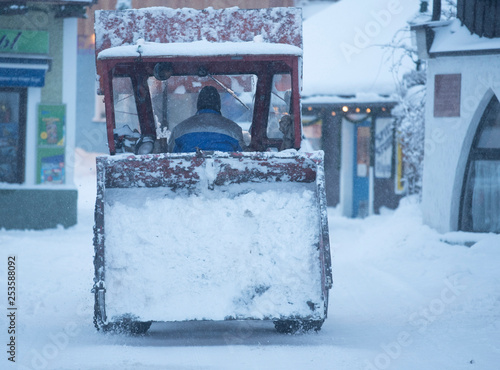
[429,19,500,54]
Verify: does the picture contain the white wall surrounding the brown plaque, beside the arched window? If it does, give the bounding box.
[422,55,500,232]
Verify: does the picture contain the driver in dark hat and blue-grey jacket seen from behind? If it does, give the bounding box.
[168,86,245,153]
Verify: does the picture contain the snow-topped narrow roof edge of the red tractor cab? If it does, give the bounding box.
[98,38,302,59]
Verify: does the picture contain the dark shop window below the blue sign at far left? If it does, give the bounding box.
[0,88,26,183]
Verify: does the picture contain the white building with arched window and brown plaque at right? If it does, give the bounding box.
[413,0,500,233]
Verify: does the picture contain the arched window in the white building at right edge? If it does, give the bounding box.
[460,97,500,233]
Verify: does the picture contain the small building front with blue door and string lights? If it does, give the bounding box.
[302,96,405,218]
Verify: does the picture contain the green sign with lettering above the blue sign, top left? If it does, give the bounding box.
[0,29,49,54]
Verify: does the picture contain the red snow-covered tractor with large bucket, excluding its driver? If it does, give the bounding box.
[92,7,332,334]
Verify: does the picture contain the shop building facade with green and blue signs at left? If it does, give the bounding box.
[0,1,92,229]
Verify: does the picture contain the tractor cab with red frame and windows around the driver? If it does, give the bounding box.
[96,11,302,155]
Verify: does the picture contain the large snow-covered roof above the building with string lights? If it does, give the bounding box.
[303,0,420,96]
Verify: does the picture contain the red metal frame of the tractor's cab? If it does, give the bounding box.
[98,55,301,154]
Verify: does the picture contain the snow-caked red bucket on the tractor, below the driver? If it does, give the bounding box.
[94,152,332,324]
